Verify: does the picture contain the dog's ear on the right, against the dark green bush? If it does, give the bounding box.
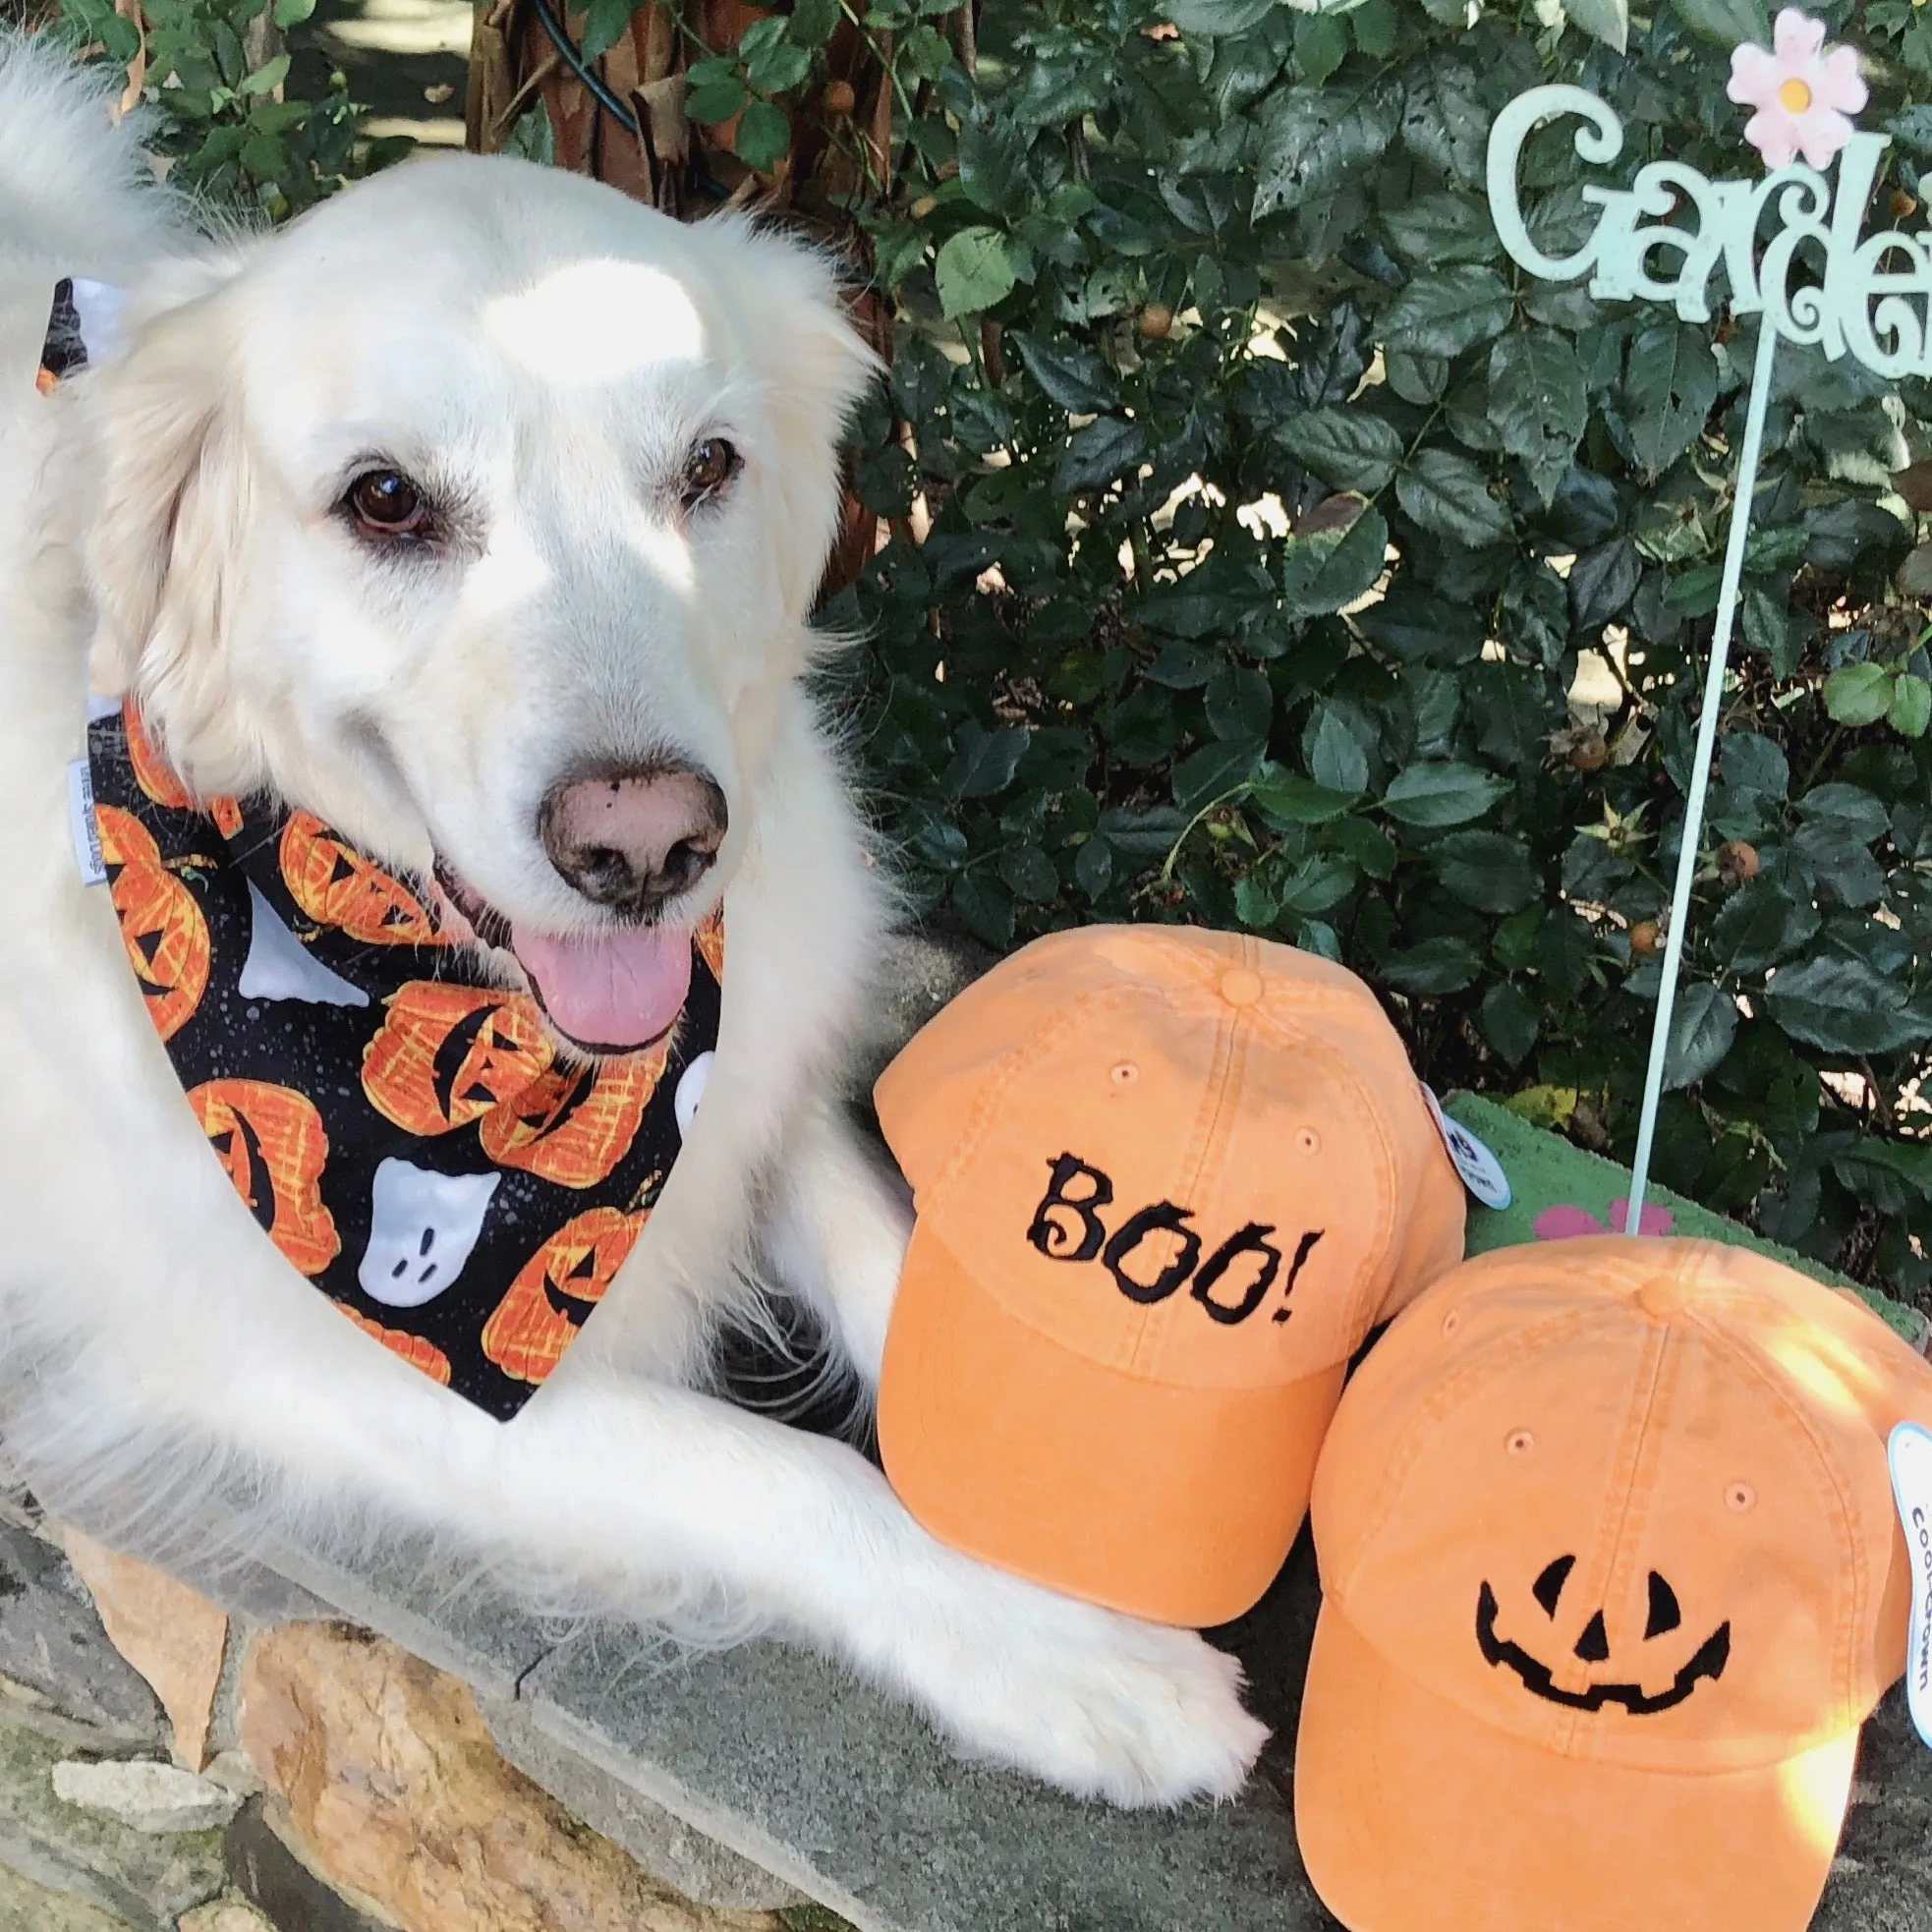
[708,220,882,620]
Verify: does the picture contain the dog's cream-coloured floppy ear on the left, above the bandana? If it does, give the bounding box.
[78,254,250,772]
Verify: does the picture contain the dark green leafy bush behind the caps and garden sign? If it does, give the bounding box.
[823,0,1932,1294]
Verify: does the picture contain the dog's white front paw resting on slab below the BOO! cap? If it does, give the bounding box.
[902,1578,1268,1806]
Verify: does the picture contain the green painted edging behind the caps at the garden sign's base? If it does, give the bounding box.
[1446,1094,1932,1348]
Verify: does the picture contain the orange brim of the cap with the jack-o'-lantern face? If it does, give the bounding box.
[1294,1604,1858,1932]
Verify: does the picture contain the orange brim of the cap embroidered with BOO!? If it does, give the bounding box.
[880,1228,1344,1628]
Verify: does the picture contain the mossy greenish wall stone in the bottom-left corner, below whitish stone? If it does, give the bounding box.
[0,1726,226,1932]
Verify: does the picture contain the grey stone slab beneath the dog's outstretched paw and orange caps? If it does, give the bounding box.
[510,1536,1932,1932]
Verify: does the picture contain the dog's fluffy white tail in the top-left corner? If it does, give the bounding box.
[0,28,178,282]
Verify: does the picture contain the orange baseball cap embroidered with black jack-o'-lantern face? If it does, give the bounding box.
[1294,1234,1932,1932]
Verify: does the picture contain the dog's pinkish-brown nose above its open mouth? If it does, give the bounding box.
[538,764,726,918]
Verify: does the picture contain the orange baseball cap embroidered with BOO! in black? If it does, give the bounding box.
[878,926,1462,1626]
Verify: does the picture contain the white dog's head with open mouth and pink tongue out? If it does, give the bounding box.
[80,158,872,1048]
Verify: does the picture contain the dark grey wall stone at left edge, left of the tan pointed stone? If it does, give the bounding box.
[0,1522,168,1754]
